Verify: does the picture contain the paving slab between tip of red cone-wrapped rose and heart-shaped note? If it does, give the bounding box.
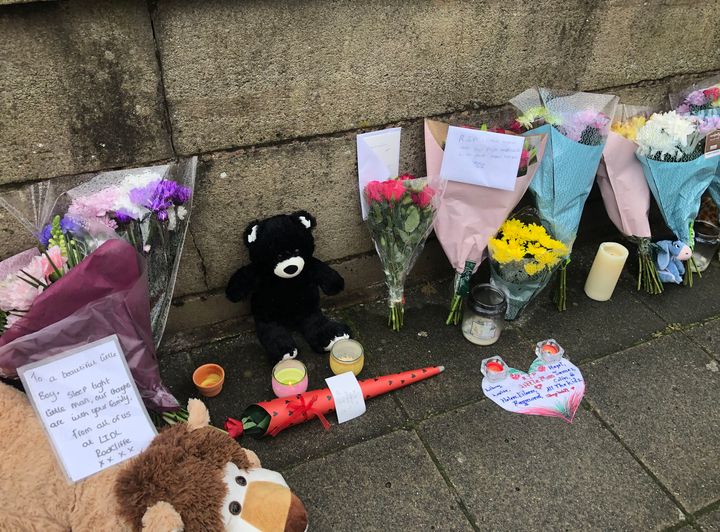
[341,282,535,419]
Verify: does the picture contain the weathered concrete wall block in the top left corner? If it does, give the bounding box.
[0,0,172,184]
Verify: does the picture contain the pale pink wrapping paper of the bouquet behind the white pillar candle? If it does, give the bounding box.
[597,131,651,238]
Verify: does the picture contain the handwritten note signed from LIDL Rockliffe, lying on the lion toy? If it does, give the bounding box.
[18,335,156,482]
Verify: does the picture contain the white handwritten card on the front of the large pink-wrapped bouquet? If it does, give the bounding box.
[440,126,525,190]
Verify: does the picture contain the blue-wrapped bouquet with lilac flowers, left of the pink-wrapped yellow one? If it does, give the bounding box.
[510,88,618,310]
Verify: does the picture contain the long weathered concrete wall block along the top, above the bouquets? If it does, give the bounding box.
[155,0,720,153]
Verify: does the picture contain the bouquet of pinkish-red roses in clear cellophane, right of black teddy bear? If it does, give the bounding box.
[364,174,444,331]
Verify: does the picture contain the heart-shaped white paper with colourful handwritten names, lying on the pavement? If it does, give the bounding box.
[482,358,585,422]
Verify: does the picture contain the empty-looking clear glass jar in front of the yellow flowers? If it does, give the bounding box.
[462,284,507,345]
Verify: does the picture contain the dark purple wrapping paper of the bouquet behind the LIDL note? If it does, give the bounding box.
[0,240,179,411]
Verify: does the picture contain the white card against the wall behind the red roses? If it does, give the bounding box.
[357,127,401,220]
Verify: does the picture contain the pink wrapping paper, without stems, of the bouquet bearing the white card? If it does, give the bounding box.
[425,120,547,273]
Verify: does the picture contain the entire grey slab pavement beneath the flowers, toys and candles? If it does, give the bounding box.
[160,239,720,532]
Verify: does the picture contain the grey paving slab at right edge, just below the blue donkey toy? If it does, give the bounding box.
[636,261,720,324]
